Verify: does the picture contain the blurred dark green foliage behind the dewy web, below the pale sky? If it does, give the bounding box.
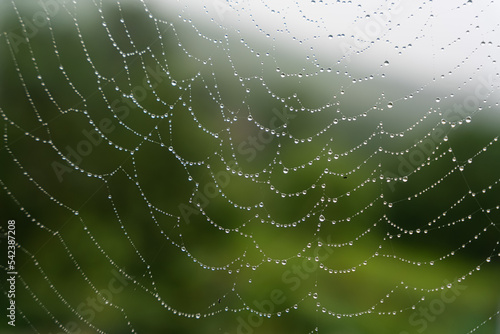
[0,1,500,333]
